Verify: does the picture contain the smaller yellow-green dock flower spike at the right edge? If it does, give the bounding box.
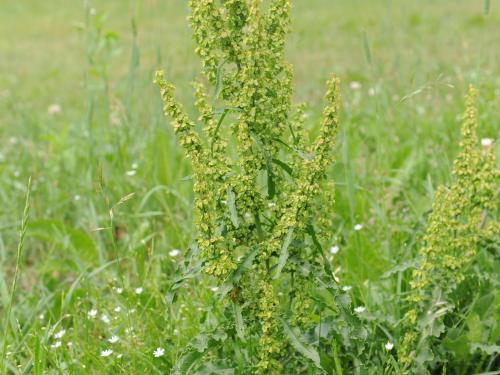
[398,86,500,366]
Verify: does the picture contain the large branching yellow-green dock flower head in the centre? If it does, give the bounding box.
[155,0,339,374]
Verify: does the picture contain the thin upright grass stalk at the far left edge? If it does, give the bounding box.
[0,176,31,374]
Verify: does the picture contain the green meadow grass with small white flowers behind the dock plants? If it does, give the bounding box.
[0,0,500,374]
